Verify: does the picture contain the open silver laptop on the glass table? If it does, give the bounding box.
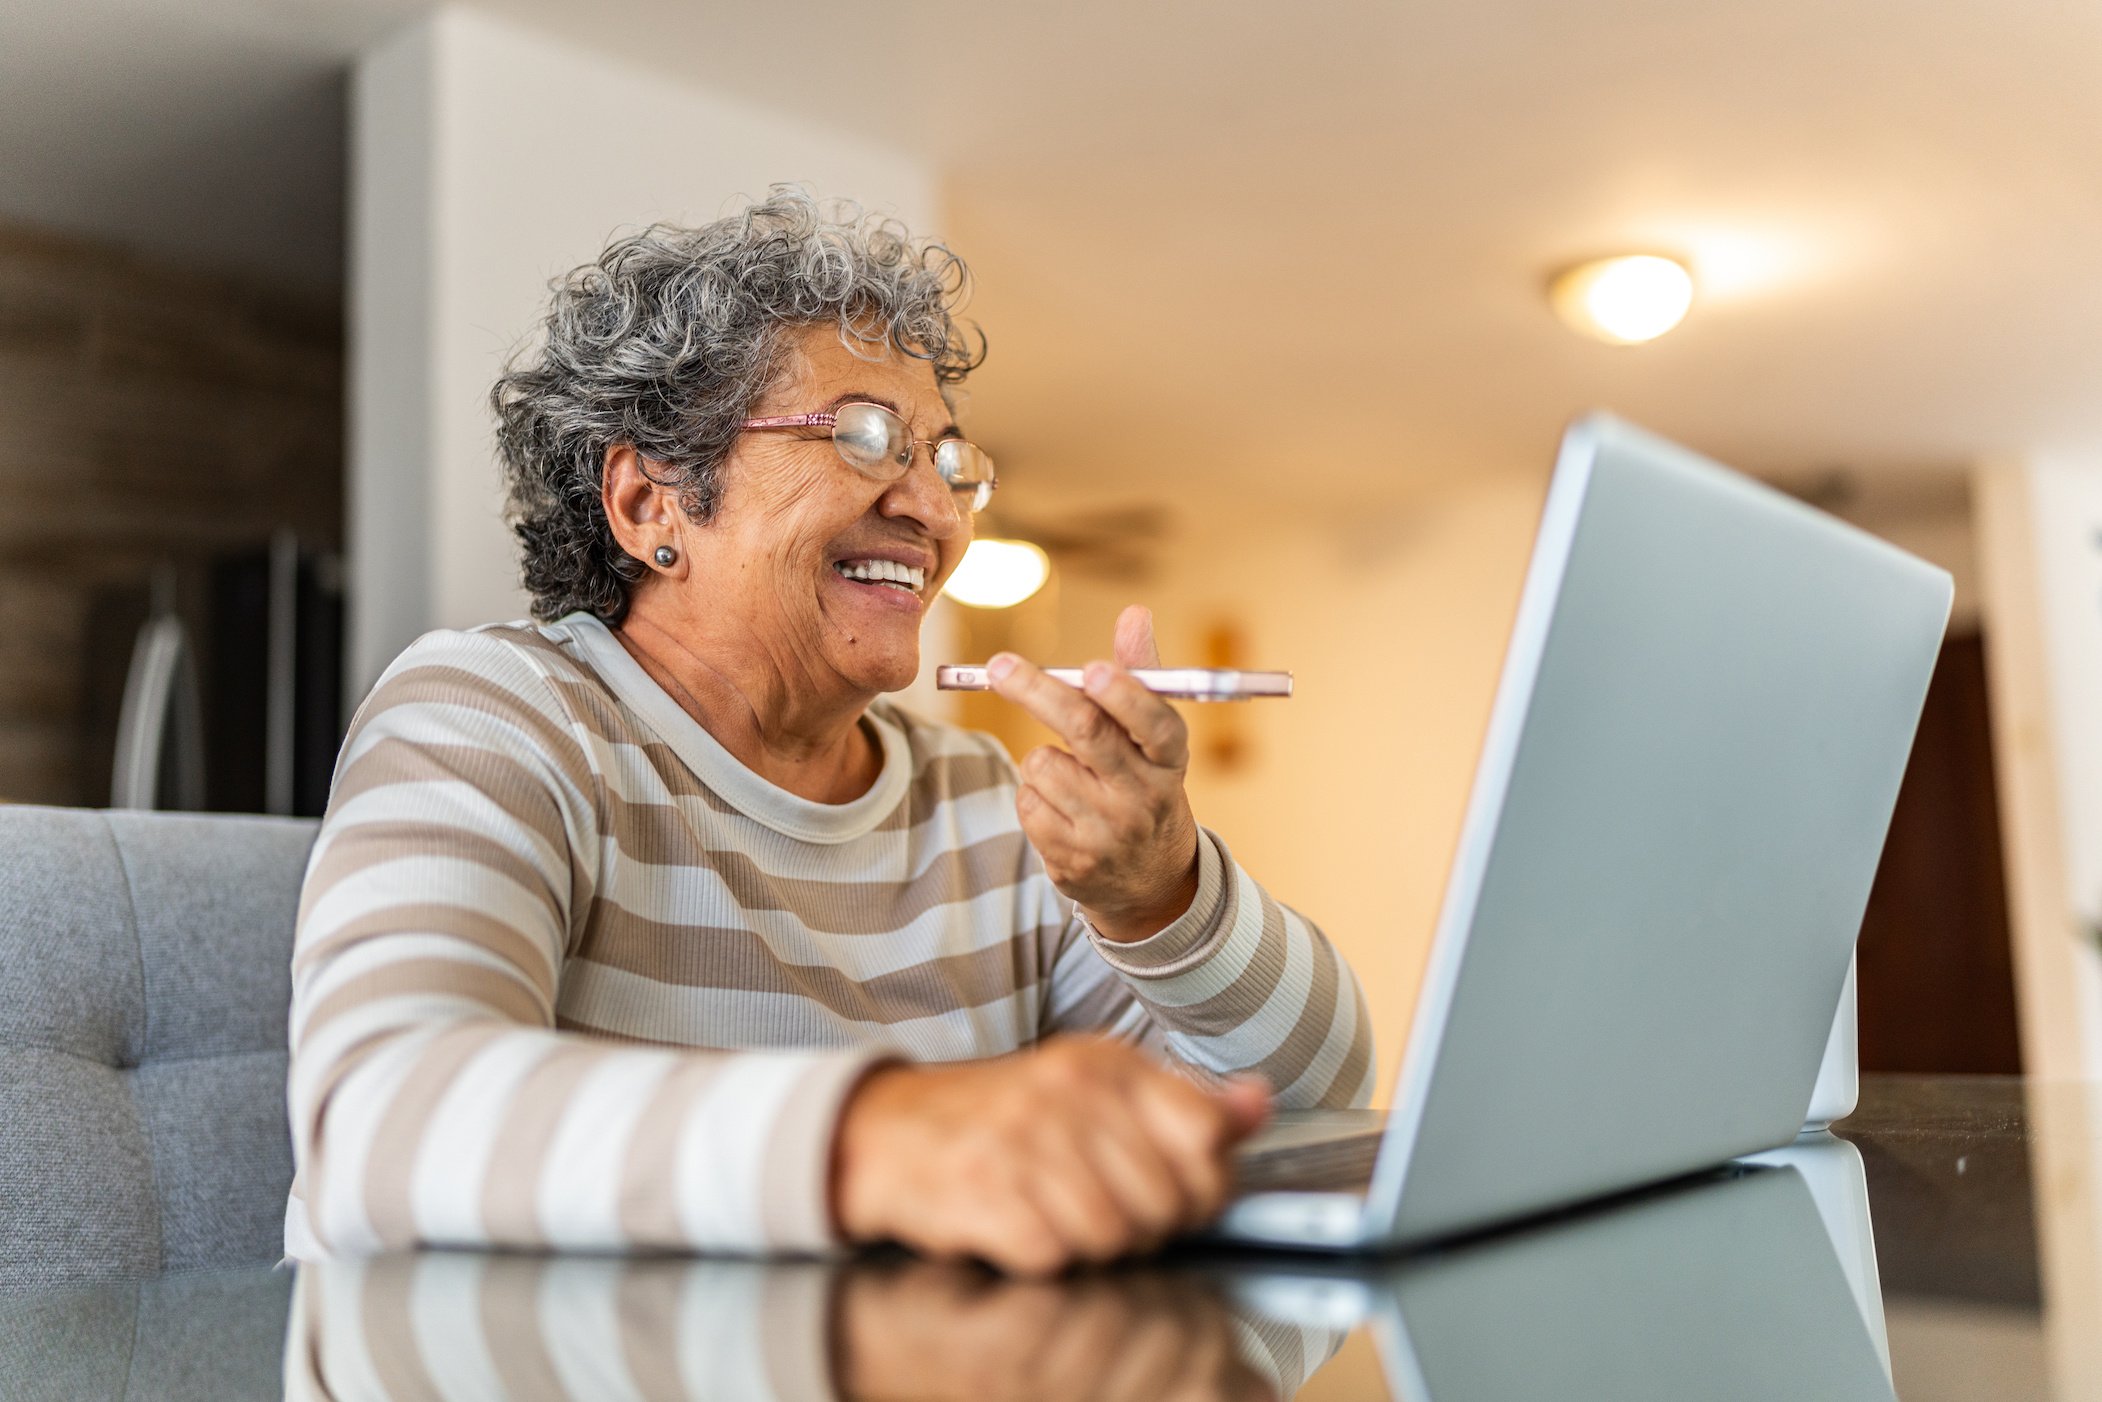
[1211,414,1953,1251]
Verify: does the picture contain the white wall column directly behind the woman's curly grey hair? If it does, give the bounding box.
[349,8,937,696]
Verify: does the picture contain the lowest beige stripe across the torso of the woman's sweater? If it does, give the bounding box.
[578,906,1036,1024]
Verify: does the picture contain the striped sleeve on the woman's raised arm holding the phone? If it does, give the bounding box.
[1045,828,1375,1110]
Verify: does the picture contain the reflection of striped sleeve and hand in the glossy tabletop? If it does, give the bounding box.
[284,1251,1343,1402]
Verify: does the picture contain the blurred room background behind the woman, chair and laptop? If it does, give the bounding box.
[0,0,2102,1378]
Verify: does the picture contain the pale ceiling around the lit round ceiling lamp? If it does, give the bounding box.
[0,0,2102,509]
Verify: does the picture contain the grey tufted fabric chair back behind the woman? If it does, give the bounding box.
[0,807,317,1288]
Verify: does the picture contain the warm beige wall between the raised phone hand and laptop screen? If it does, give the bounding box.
[963,473,1547,1104]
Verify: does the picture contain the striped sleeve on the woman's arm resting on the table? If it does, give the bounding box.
[286,633,879,1257]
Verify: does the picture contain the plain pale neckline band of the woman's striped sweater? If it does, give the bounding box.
[555,612,912,843]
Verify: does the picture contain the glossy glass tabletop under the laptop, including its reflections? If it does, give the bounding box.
[0,1078,2102,1402]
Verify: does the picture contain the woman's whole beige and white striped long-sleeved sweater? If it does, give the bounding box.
[286,614,1373,1259]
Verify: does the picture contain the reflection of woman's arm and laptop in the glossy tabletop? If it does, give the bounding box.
[271,1135,1892,1402]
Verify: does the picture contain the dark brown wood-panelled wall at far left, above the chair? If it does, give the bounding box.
[0,227,343,803]
